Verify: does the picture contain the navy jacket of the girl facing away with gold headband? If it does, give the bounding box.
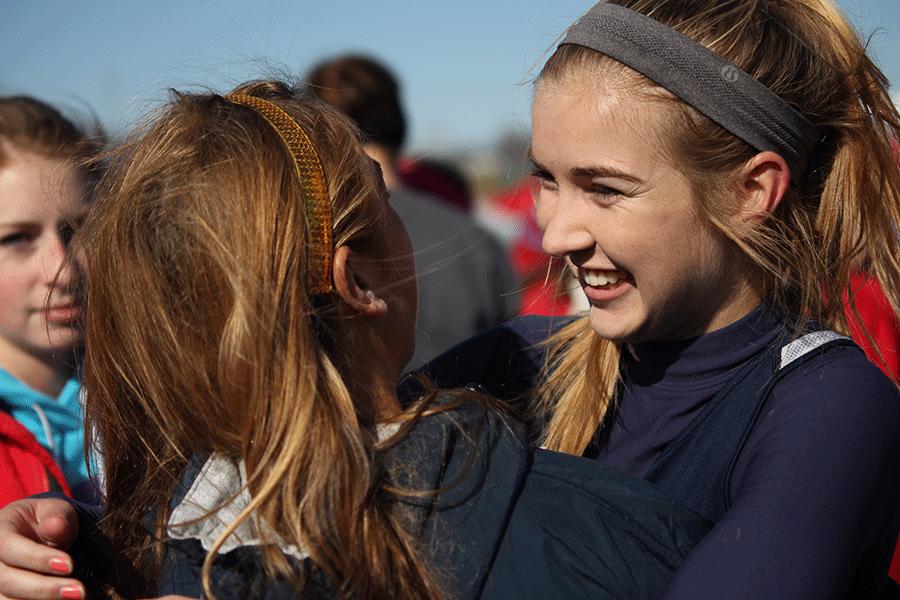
[61,406,710,600]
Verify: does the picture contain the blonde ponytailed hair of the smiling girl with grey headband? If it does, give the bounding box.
[536,0,900,454]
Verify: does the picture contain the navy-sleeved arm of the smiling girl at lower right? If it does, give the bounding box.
[664,349,900,600]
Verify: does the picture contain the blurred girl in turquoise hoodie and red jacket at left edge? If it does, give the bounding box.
[0,97,98,506]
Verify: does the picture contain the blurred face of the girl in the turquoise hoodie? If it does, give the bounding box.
[0,151,85,364]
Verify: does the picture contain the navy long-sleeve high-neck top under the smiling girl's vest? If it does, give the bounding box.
[429,305,900,600]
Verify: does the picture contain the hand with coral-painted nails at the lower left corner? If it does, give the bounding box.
[0,498,85,600]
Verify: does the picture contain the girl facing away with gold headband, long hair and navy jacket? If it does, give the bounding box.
[0,81,709,600]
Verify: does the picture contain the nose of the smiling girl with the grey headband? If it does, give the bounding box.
[536,190,594,258]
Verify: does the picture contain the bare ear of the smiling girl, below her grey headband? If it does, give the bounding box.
[735,151,791,229]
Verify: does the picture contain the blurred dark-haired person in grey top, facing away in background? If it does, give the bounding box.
[306,55,519,368]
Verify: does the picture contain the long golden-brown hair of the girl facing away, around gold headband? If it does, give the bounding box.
[81,82,440,598]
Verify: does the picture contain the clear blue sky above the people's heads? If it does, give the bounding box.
[0,0,900,151]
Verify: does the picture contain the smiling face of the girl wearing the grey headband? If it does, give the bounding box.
[531,77,761,343]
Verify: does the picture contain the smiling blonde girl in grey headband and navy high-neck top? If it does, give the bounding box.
[531,0,900,599]
